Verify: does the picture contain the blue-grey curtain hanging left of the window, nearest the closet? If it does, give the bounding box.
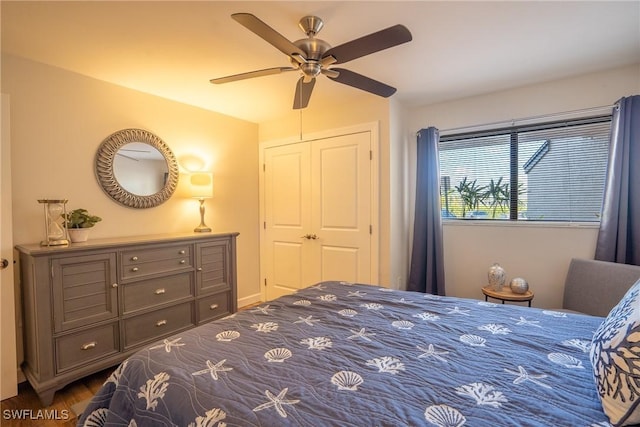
[407,127,445,295]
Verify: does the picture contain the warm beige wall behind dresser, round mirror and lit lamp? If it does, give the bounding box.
[2,56,260,304]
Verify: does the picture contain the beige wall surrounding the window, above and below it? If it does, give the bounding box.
[409,64,640,308]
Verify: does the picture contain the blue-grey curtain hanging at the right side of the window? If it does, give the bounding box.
[595,95,640,265]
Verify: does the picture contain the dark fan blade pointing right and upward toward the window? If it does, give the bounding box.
[324,24,412,64]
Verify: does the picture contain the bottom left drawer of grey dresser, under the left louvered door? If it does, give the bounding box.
[55,322,119,372]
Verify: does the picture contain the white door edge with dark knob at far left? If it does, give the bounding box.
[0,94,18,399]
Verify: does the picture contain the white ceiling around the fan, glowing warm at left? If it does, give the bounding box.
[1,0,640,123]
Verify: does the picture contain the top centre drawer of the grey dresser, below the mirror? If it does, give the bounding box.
[120,244,193,280]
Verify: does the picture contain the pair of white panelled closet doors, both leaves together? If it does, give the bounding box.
[262,132,372,299]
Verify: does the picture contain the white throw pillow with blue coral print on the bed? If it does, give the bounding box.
[590,280,640,427]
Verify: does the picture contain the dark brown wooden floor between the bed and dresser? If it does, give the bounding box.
[0,302,261,427]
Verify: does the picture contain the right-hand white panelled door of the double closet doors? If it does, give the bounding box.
[311,132,371,283]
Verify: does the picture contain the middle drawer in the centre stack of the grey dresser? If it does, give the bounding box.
[121,271,194,314]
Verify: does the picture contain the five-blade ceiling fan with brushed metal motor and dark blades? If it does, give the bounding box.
[210,13,412,110]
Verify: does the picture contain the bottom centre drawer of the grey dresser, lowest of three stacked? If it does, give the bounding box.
[124,302,195,348]
